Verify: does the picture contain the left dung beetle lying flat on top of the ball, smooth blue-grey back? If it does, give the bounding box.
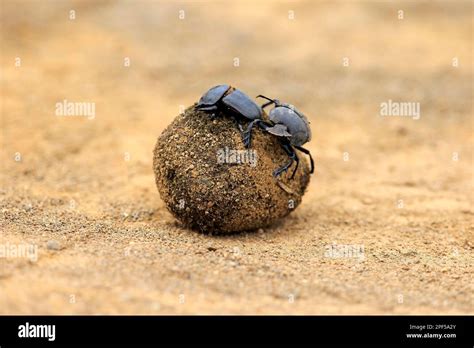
[196,85,262,126]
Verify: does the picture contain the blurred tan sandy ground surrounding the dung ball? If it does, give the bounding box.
[0,0,474,314]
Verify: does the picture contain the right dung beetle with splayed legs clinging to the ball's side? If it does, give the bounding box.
[244,95,314,179]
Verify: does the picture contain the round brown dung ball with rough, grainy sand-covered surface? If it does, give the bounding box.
[153,106,310,233]
